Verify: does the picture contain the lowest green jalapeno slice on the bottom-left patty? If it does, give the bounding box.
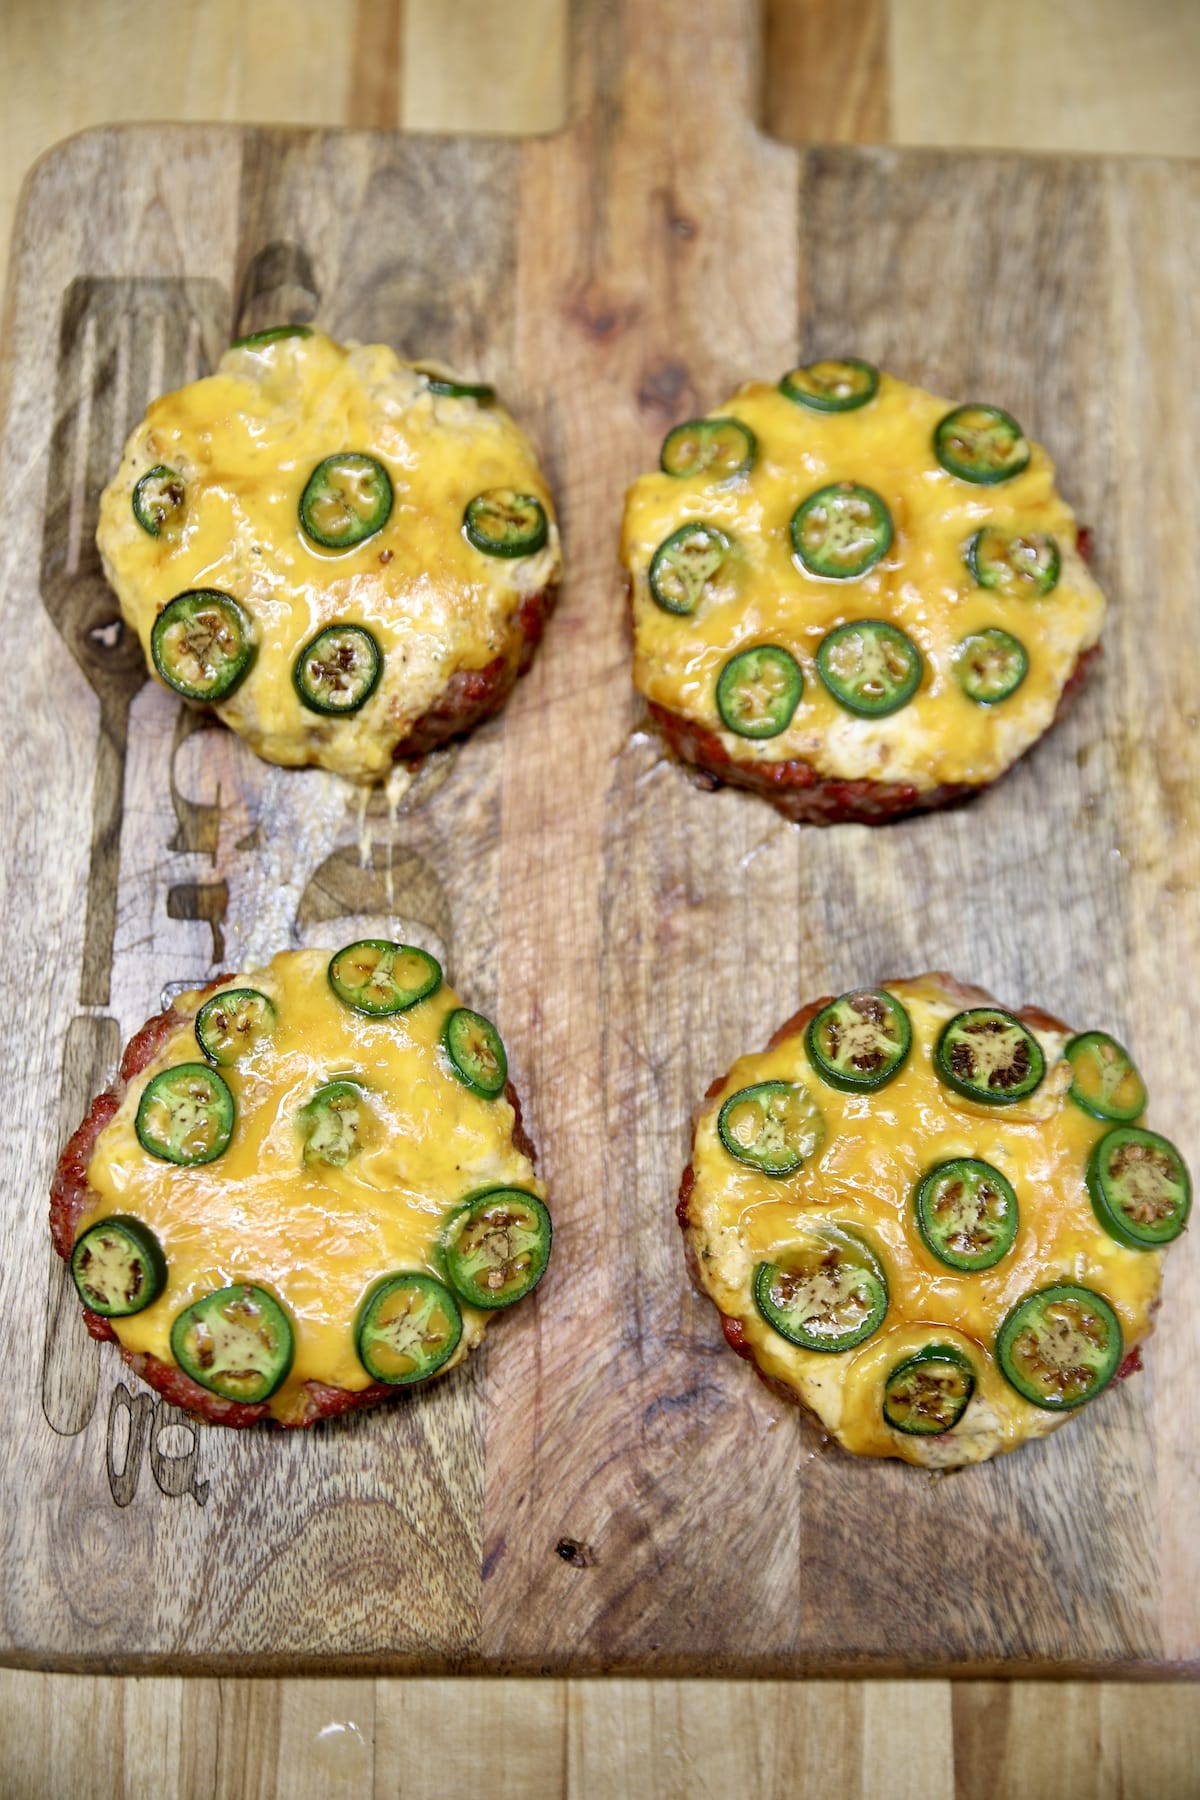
[171,1282,293,1406]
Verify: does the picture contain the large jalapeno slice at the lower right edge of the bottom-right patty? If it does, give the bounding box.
[997,1282,1121,1413]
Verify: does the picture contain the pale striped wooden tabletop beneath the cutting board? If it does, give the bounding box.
[0,0,1200,1800]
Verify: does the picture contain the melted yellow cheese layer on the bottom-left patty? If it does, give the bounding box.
[79,950,545,1418]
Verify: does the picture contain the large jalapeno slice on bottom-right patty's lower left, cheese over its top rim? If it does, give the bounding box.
[754,1226,887,1354]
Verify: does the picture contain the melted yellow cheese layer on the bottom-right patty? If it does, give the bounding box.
[687,976,1162,1467]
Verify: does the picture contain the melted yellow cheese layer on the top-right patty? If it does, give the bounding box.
[622,374,1105,790]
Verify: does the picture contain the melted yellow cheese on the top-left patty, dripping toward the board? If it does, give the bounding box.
[97,331,561,781]
